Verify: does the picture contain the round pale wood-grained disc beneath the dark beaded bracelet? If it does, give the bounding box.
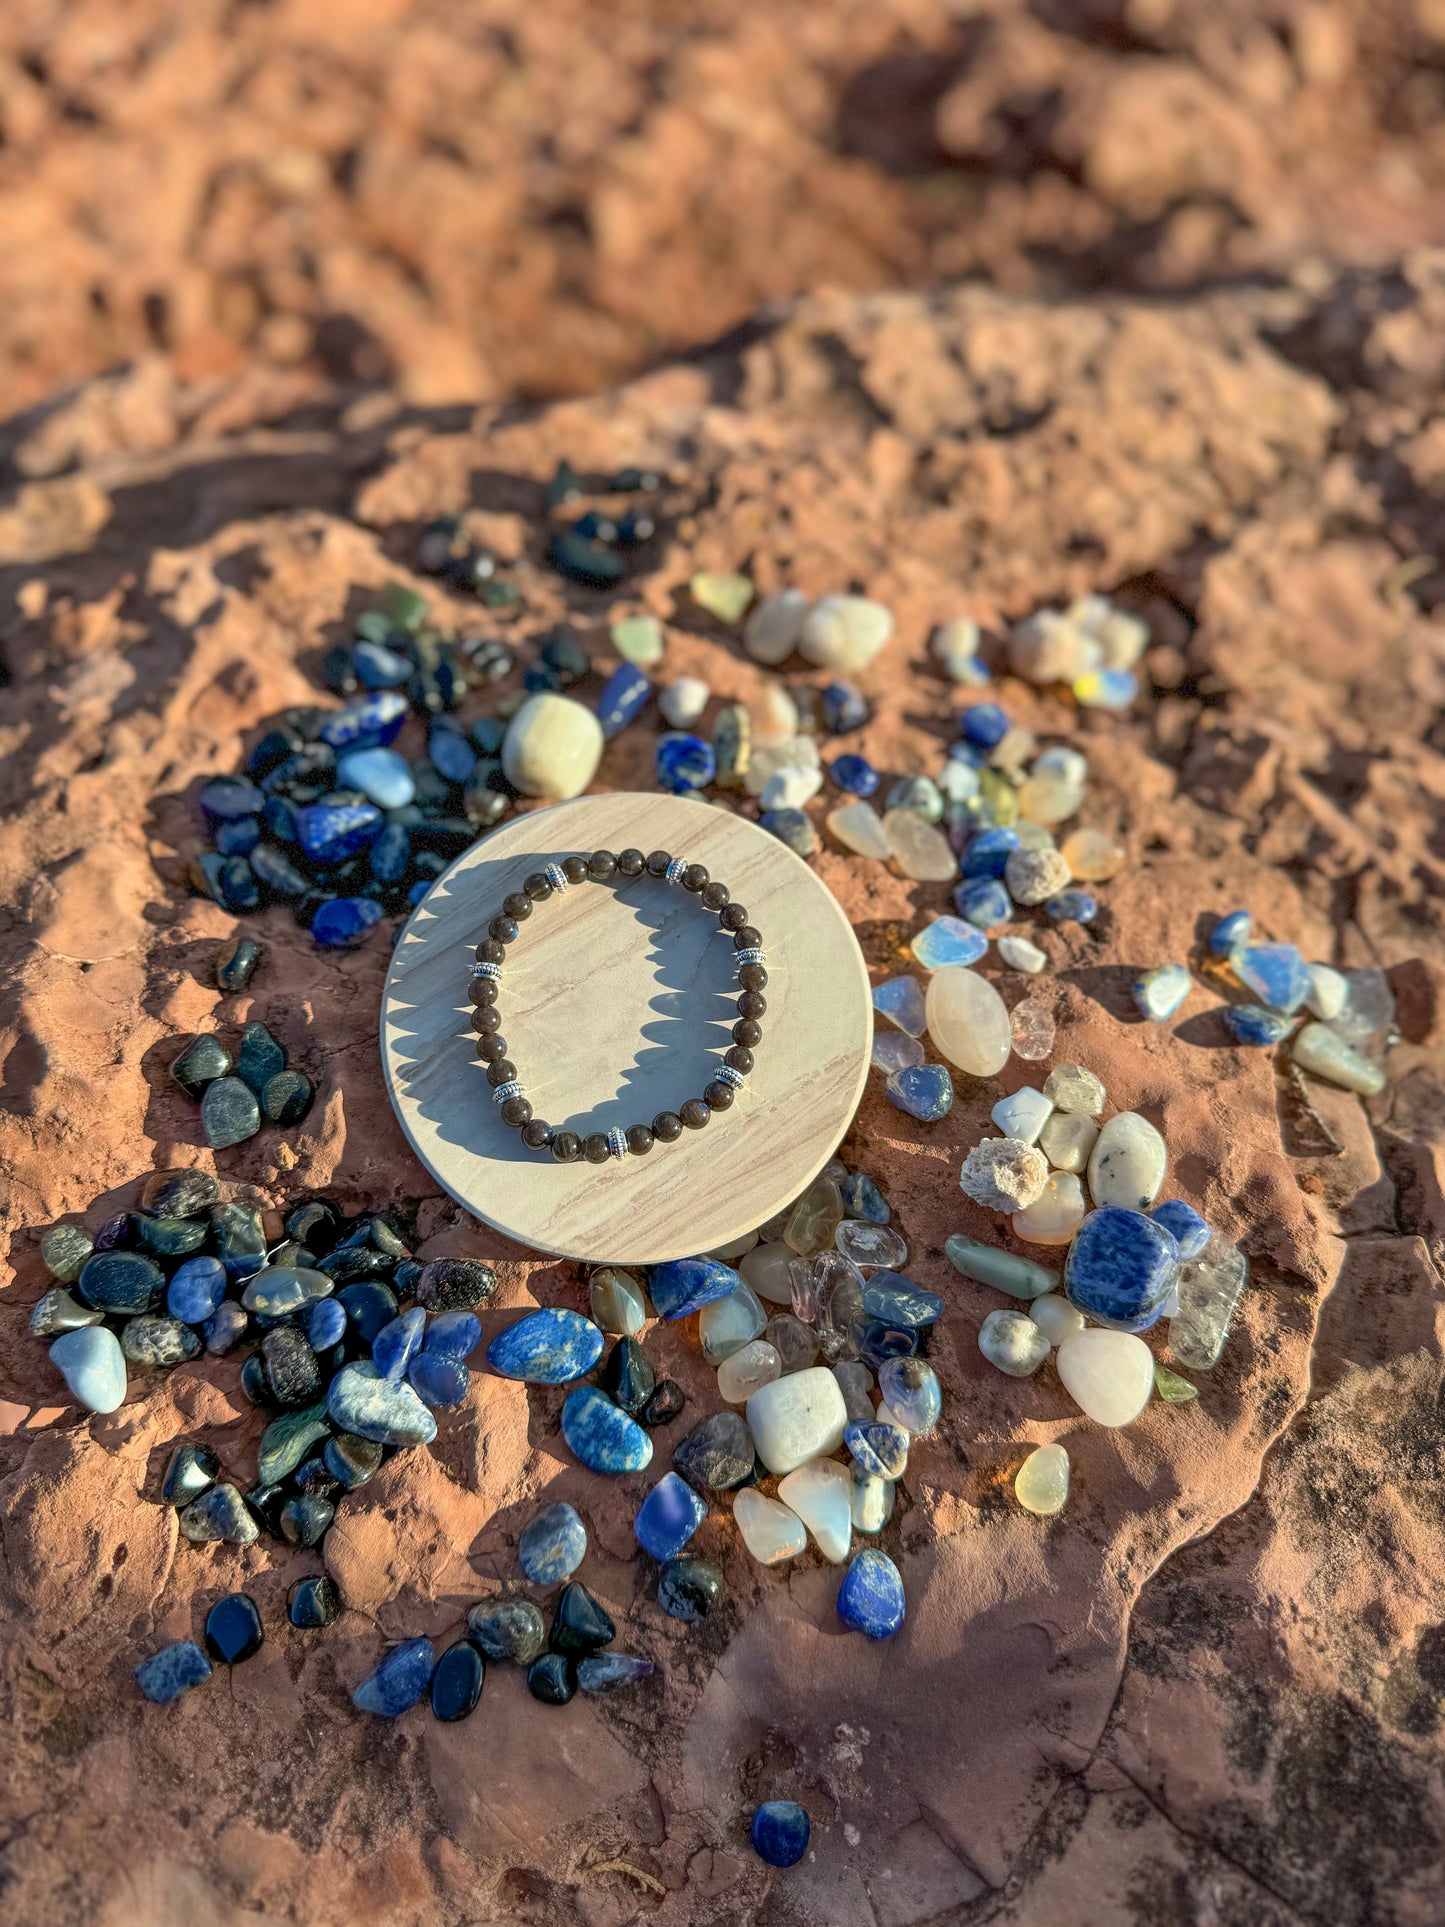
[381,794,873,1264]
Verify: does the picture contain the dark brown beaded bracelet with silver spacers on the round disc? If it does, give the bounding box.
[468,850,767,1164]
